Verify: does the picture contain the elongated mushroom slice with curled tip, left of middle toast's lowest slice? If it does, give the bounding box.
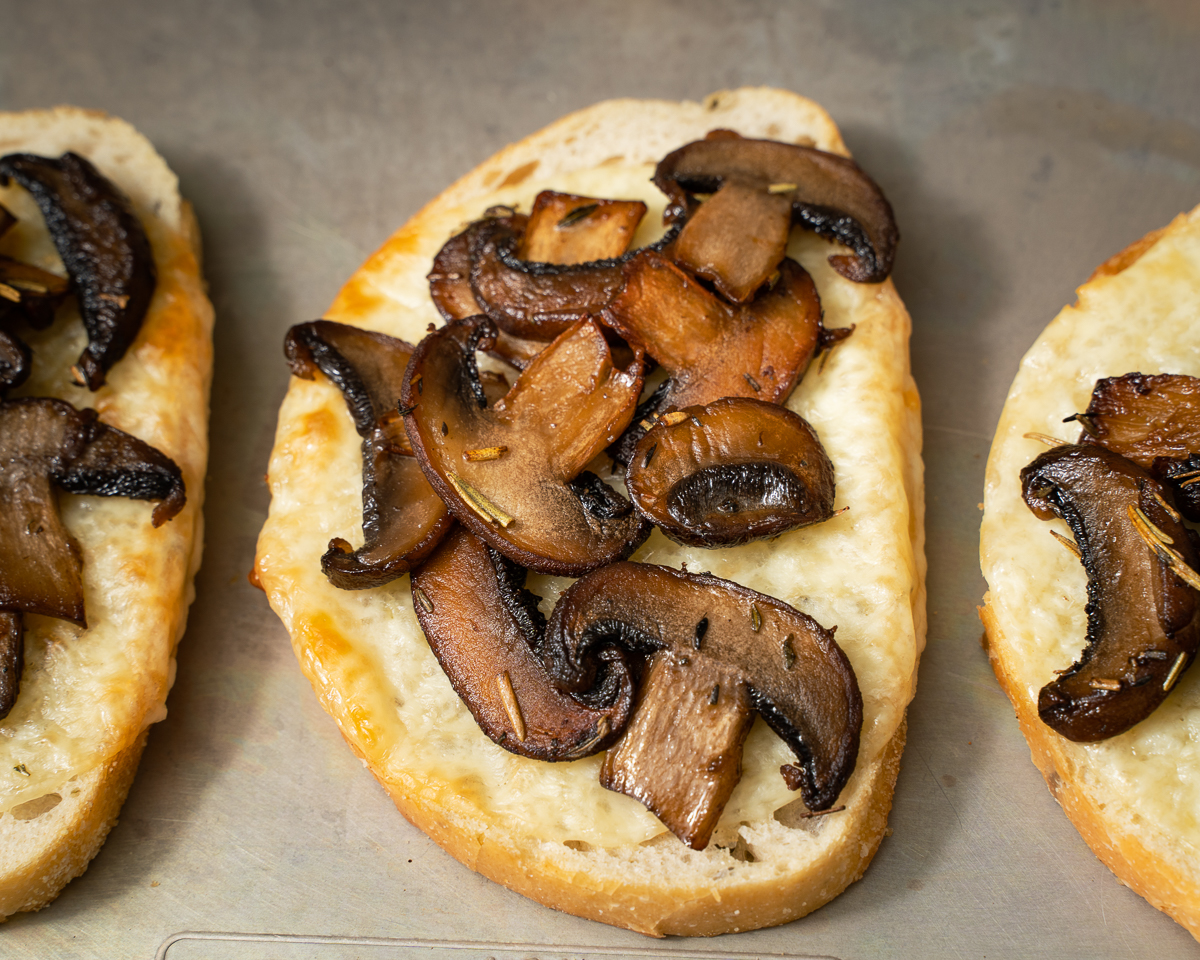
[413,527,634,761]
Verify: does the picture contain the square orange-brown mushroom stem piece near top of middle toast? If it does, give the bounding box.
[516,190,646,264]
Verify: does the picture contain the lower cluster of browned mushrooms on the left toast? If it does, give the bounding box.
[0,398,186,718]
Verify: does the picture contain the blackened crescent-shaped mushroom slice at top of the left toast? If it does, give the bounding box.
[0,154,156,390]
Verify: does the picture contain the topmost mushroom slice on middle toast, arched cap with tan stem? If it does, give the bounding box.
[654,131,900,294]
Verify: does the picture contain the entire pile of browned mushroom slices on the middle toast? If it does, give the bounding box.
[287,131,898,850]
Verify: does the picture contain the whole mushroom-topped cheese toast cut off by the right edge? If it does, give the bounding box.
[980,208,1200,937]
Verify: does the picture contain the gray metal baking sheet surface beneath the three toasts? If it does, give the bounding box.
[0,0,1200,960]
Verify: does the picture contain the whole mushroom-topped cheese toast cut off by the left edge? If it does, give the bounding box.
[0,107,212,917]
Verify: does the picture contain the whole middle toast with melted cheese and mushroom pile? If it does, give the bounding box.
[256,89,925,935]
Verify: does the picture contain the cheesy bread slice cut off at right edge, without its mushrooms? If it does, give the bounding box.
[980,208,1200,935]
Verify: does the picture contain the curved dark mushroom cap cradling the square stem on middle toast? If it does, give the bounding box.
[470,214,624,341]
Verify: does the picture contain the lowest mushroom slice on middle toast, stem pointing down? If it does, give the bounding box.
[544,563,863,850]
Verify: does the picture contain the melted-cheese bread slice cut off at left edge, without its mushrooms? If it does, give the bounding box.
[0,107,212,917]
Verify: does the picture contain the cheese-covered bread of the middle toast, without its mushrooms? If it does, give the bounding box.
[257,90,924,935]
